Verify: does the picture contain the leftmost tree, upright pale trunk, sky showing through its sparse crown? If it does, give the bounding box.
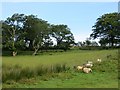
[2,13,24,56]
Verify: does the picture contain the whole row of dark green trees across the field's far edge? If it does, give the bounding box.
[0,12,120,56]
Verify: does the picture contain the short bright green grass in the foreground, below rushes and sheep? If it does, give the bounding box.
[3,72,118,88]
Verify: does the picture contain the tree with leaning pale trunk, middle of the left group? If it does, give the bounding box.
[33,19,50,55]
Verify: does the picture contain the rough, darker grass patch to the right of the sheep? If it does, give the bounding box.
[93,54,119,73]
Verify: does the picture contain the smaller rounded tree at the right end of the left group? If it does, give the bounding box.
[51,25,74,50]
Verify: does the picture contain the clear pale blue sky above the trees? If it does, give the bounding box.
[1,2,118,42]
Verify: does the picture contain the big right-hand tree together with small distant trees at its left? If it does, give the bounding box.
[77,12,120,48]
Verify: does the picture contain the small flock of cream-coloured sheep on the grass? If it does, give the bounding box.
[74,59,101,73]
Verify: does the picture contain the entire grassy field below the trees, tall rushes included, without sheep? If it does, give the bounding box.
[3,50,119,88]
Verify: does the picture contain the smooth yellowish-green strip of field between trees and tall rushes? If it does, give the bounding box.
[2,50,118,67]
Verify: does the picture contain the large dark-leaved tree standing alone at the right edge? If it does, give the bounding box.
[90,13,120,46]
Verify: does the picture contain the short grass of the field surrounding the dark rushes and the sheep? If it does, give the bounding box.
[2,50,118,88]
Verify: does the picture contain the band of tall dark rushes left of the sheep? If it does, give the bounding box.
[2,64,70,83]
